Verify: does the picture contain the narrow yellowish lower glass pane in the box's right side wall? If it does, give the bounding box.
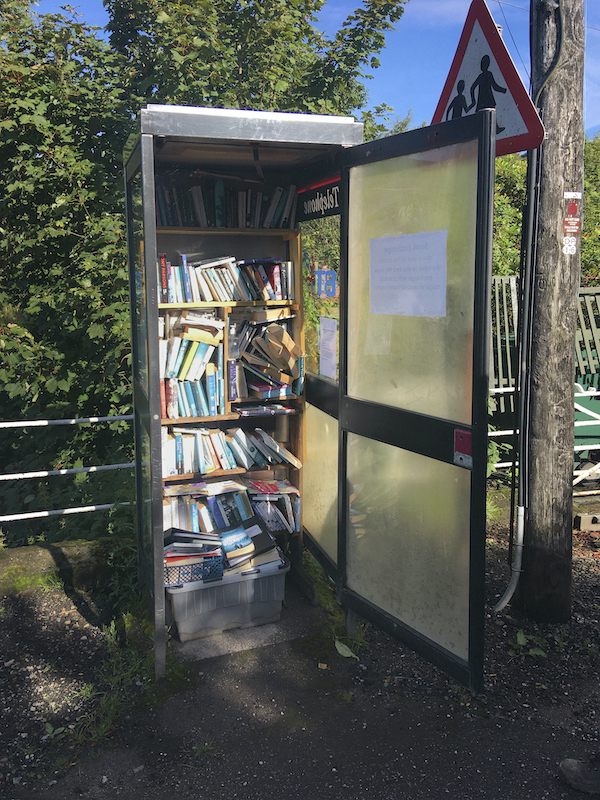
[302,403,338,563]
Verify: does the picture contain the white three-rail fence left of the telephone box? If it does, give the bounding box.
[0,414,135,522]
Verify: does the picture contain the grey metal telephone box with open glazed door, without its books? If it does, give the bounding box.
[125,105,495,689]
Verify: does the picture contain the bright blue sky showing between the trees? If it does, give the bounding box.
[36,0,600,135]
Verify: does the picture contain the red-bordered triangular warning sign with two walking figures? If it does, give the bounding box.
[432,0,544,156]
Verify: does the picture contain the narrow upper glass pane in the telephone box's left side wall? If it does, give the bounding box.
[129,172,148,396]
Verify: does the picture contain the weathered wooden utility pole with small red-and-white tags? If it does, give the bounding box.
[516,0,584,622]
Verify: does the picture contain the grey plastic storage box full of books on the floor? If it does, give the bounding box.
[166,559,290,642]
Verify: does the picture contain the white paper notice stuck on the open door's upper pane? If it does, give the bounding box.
[370,230,448,317]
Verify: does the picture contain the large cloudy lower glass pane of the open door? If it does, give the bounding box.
[347,434,471,660]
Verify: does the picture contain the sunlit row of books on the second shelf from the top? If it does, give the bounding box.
[158,253,294,304]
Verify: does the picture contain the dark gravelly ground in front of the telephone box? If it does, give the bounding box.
[0,512,600,800]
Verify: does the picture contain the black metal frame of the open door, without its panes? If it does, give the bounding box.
[332,110,496,690]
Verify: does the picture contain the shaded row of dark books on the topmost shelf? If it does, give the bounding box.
[156,170,297,228]
